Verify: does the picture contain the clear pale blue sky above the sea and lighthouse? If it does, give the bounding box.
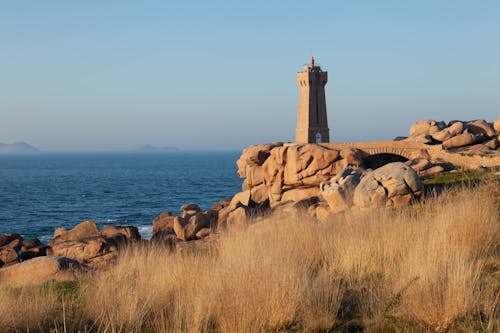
[0,0,500,151]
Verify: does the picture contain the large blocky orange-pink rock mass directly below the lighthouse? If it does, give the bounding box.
[234,143,363,209]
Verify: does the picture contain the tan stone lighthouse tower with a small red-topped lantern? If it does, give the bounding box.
[295,57,330,143]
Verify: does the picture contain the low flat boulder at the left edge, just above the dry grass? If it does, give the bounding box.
[0,256,88,287]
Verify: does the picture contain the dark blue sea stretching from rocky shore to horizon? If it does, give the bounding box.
[0,152,241,241]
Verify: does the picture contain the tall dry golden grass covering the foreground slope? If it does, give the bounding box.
[0,183,500,333]
